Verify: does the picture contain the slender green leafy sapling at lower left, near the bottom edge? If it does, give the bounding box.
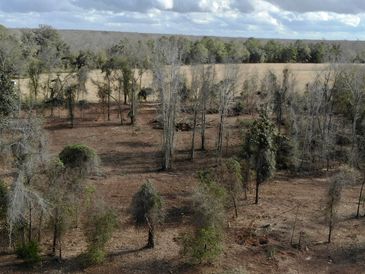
[86,208,117,265]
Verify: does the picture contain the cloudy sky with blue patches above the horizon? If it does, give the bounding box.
[0,0,365,40]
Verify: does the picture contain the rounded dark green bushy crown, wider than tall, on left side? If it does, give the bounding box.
[59,144,97,168]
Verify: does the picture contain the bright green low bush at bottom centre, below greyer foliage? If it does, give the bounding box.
[182,227,223,264]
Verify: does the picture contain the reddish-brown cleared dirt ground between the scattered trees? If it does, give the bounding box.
[0,103,365,274]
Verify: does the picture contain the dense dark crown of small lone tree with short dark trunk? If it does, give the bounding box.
[131,181,163,226]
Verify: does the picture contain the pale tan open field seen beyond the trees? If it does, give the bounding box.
[19,64,328,102]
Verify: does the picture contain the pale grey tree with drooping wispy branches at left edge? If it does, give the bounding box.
[1,113,49,248]
